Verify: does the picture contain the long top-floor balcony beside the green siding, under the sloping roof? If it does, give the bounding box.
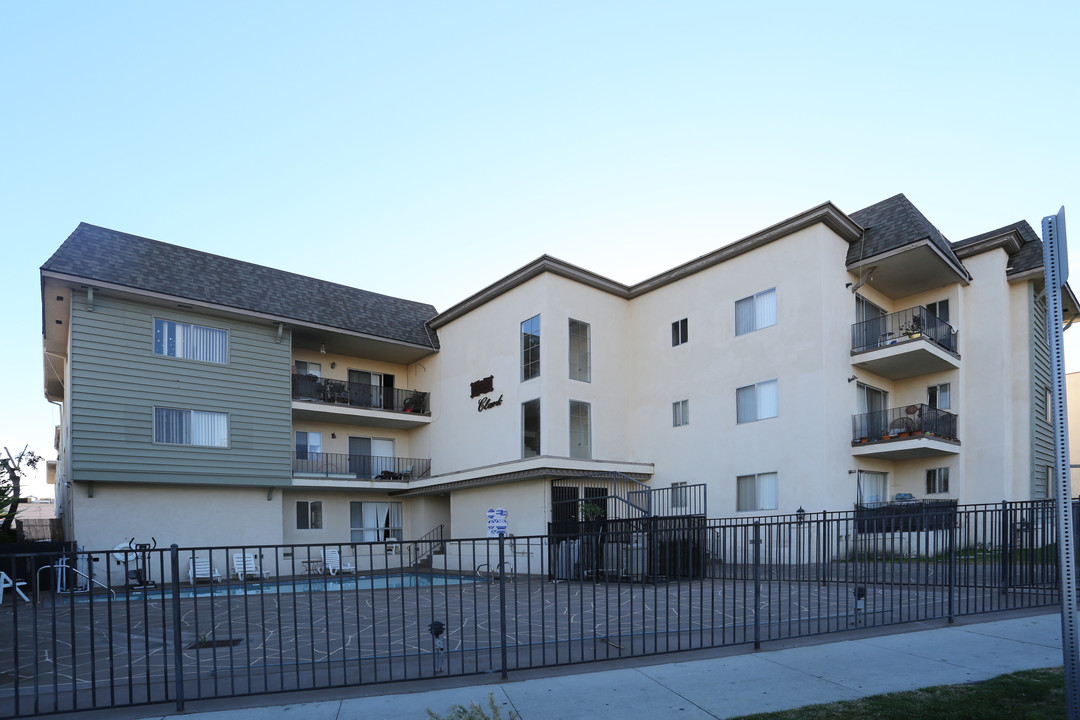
[293,373,431,427]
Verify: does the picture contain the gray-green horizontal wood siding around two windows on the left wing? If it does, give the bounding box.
[68,293,293,486]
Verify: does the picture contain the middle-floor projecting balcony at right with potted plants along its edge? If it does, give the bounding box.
[851,405,960,460]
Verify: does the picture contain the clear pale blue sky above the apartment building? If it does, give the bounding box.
[0,0,1080,496]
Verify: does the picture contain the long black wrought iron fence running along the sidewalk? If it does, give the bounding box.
[0,502,1059,717]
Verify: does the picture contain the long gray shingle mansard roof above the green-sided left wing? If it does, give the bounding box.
[41,222,438,349]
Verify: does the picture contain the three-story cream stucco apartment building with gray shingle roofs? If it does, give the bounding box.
[41,195,1077,547]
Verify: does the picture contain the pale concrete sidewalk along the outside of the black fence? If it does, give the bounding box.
[105,612,1062,720]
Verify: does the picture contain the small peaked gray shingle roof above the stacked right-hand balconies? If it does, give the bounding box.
[848,193,968,275]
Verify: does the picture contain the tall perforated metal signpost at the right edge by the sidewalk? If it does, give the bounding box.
[1042,207,1080,720]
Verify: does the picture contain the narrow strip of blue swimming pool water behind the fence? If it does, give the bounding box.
[83,572,477,601]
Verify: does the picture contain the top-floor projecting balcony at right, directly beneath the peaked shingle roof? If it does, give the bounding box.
[851,305,960,380]
